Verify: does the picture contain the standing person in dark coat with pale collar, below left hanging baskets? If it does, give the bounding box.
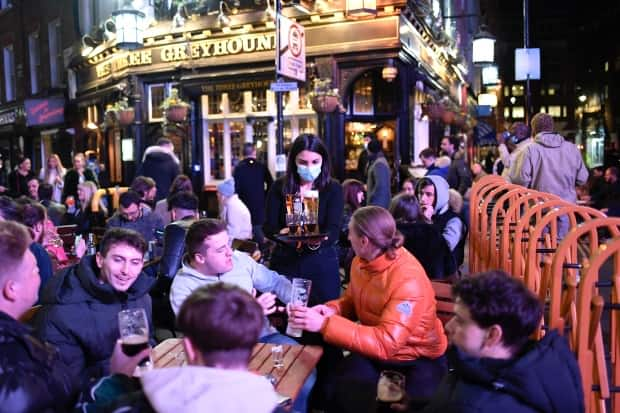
[136,138,181,202]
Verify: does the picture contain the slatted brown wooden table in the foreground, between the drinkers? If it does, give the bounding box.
[153,338,323,400]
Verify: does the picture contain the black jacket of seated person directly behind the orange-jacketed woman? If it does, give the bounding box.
[396,222,457,280]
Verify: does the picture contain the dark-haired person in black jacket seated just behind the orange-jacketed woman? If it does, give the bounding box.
[390,193,457,280]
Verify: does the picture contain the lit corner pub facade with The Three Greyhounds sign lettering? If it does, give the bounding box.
[70,1,468,186]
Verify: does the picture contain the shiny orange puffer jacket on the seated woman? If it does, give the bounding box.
[321,248,448,361]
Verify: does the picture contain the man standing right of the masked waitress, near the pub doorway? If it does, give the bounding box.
[366,139,392,209]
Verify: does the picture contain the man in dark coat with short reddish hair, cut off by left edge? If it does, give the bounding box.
[0,221,76,413]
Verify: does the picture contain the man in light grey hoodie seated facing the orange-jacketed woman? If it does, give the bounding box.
[170,219,316,412]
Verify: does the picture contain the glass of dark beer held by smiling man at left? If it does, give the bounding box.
[118,308,152,369]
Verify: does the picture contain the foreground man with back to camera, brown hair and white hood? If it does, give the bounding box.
[81,282,281,413]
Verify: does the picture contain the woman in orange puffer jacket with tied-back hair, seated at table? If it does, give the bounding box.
[289,206,448,412]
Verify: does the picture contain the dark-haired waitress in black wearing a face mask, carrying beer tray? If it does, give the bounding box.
[264,134,344,305]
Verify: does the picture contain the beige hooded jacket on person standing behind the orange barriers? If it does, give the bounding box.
[510,132,588,203]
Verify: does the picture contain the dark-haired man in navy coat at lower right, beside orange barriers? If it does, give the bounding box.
[410,271,585,413]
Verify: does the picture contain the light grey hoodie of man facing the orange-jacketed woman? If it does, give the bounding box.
[170,251,292,337]
